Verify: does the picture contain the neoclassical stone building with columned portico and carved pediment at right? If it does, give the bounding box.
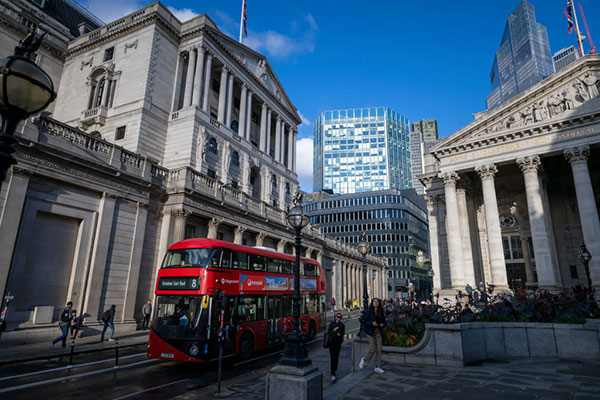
[419,55,600,294]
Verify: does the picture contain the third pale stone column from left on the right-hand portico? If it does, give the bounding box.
[476,164,509,293]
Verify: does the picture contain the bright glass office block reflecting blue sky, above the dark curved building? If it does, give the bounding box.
[313,107,412,194]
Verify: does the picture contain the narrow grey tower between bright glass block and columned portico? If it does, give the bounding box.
[410,119,438,194]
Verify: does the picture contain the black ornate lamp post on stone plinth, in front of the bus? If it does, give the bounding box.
[281,192,311,367]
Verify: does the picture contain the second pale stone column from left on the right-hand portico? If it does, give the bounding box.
[440,172,464,290]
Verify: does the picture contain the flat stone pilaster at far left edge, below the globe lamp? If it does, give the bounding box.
[0,165,31,301]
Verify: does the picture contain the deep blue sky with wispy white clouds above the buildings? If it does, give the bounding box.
[79,0,600,191]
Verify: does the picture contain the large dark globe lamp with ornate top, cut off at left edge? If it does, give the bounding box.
[0,25,56,182]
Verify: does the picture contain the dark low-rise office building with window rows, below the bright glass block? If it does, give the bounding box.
[306,189,432,304]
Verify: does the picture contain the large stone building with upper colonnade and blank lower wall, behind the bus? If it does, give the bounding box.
[0,3,385,338]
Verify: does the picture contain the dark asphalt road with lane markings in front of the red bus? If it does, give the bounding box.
[0,318,358,400]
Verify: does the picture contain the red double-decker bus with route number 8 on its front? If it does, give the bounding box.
[148,239,326,362]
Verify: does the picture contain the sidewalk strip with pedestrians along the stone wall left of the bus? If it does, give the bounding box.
[0,329,150,366]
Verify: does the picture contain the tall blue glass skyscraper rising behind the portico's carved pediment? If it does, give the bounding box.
[487,0,554,110]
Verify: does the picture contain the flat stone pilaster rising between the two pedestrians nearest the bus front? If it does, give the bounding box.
[120,202,148,322]
